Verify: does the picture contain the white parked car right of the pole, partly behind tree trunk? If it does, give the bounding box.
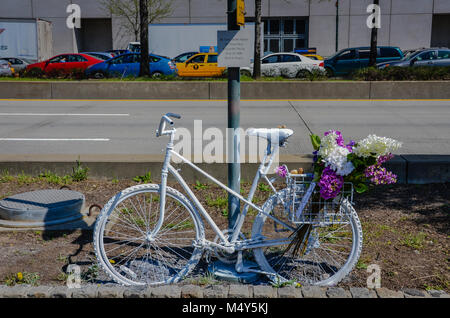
[241,53,325,78]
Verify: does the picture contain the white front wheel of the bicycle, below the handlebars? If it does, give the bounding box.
[94,184,204,285]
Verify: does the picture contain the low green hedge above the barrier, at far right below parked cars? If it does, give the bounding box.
[350,66,450,81]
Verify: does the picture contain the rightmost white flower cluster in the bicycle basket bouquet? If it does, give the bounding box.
[353,135,402,158]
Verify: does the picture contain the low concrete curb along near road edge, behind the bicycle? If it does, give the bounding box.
[0,154,450,184]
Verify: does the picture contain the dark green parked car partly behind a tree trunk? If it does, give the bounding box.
[325,46,404,76]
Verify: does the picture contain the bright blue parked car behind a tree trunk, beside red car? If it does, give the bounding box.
[86,53,177,79]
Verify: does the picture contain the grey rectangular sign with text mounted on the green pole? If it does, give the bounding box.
[217,28,254,67]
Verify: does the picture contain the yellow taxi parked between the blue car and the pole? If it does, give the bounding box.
[177,53,226,77]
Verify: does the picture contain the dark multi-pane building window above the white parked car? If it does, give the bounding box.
[263,17,308,53]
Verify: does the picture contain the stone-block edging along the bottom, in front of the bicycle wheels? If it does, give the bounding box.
[0,285,450,299]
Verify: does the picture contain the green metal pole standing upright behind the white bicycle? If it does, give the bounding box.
[227,0,241,229]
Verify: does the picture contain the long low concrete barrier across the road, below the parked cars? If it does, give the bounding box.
[0,81,450,100]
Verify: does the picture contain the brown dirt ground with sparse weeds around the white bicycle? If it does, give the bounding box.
[0,177,450,292]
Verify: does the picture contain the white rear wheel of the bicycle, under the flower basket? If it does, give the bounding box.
[252,189,362,286]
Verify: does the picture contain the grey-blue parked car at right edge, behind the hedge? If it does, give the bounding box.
[377,48,450,69]
